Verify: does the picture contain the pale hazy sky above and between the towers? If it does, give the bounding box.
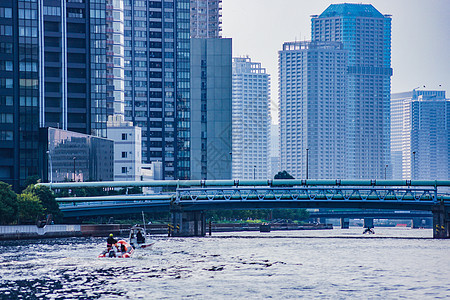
[222,0,450,113]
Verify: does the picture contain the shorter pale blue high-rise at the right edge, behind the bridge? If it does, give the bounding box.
[391,90,450,180]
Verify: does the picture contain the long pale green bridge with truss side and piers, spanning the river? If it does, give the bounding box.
[41,179,450,238]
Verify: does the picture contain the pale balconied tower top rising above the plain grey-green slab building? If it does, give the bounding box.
[190,0,222,38]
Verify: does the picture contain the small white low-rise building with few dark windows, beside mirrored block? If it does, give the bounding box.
[108,115,142,181]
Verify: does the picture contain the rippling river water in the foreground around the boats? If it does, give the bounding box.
[0,228,450,299]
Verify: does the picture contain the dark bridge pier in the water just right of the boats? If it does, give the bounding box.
[171,209,206,237]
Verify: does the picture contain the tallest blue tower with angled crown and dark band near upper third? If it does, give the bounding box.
[311,3,392,178]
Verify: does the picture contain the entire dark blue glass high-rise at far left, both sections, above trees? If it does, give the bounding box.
[0,0,106,189]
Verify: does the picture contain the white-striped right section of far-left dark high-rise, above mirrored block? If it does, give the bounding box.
[42,0,107,137]
